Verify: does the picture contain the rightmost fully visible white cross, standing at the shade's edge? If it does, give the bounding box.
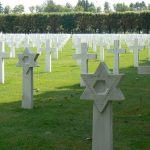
[129,39,144,67]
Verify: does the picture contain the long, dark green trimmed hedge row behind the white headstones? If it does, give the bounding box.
[0,11,150,33]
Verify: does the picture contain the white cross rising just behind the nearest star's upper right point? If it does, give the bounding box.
[107,40,125,74]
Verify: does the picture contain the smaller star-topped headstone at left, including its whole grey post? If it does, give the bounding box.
[17,48,39,109]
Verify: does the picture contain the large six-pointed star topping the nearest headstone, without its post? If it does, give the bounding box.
[80,62,124,112]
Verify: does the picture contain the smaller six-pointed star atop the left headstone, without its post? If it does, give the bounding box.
[17,48,39,74]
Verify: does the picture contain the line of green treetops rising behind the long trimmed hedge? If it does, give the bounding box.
[0,0,150,14]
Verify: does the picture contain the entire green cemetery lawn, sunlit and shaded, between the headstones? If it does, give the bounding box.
[0,40,150,150]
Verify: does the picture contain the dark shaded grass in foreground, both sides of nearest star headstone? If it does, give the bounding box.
[0,63,150,150]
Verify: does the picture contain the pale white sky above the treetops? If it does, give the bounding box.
[0,0,150,12]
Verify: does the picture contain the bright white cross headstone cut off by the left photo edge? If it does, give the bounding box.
[0,42,12,84]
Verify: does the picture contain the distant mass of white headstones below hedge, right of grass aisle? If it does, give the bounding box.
[72,34,150,61]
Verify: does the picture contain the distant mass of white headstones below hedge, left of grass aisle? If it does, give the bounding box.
[0,34,70,59]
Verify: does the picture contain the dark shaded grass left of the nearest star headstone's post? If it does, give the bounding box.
[0,85,92,150]
